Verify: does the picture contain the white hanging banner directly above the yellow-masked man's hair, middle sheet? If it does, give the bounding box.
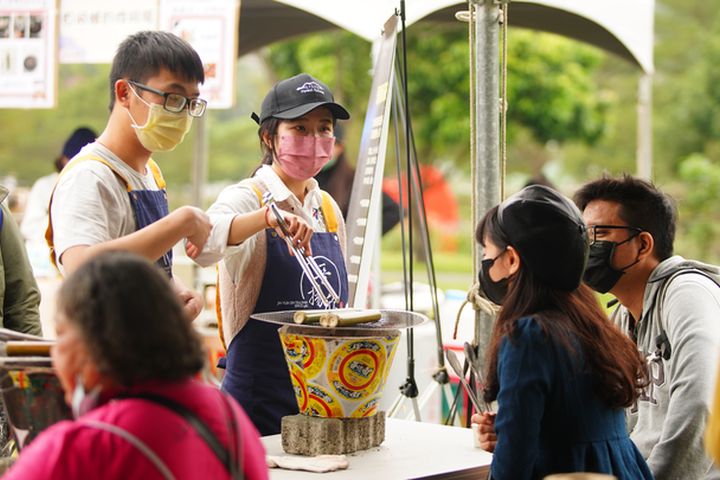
[60,0,158,63]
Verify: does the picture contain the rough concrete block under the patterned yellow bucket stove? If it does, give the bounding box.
[281,412,385,456]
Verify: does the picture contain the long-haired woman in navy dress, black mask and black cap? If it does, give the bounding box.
[473,185,652,479]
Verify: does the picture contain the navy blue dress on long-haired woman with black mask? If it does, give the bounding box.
[492,318,652,480]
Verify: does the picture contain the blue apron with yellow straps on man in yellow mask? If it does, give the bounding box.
[45,154,172,277]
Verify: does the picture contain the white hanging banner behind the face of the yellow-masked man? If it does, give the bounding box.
[159,0,240,108]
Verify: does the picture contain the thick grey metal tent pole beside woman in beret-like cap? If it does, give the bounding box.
[470,0,501,352]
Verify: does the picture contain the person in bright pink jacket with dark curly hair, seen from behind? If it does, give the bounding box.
[3,252,268,480]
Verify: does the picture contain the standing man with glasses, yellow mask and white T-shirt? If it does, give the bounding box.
[46,31,211,319]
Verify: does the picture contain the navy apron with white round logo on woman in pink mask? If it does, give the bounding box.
[222,186,348,436]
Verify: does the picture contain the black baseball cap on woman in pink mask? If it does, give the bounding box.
[251,73,350,123]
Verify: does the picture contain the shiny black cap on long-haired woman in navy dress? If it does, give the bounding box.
[497,185,589,291]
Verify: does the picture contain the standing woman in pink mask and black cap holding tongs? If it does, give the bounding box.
[186,74,350,435]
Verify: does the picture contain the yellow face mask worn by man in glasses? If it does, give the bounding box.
[127,88,192,152]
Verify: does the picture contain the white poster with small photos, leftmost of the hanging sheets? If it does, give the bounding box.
[0,0,58,108]
